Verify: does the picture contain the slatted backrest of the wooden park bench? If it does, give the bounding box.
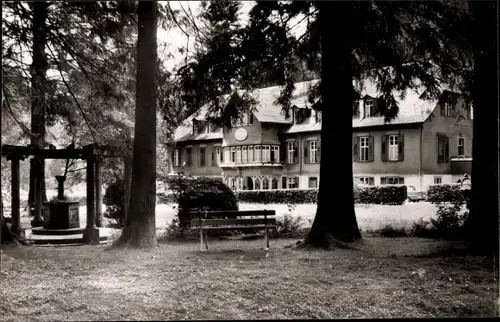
[190,210,276,228]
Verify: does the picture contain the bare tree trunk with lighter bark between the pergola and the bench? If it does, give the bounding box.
[114,1,158,248]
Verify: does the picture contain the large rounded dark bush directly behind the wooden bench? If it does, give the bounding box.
[167,176,238,230]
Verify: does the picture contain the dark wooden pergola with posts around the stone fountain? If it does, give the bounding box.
[1,144,123,245]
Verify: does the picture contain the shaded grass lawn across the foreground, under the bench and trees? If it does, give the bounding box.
[0,238,498,321]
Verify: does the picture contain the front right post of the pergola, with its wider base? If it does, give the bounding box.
[83,148,99,245]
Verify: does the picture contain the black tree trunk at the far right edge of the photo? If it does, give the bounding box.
[465,1,499,258]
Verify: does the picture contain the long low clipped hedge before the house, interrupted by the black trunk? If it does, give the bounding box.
[236,185,407,205]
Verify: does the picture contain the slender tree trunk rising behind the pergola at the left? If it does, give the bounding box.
[28,1,48,219]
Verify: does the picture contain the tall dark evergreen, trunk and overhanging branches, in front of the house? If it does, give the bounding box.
[175,1,470,248]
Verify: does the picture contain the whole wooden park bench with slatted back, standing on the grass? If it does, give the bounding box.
[189,210,276,251]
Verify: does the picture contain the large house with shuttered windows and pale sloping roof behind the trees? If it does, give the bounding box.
[169,81,472,191]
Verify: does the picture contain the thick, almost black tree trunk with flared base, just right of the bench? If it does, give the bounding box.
[300,1,361,249]
